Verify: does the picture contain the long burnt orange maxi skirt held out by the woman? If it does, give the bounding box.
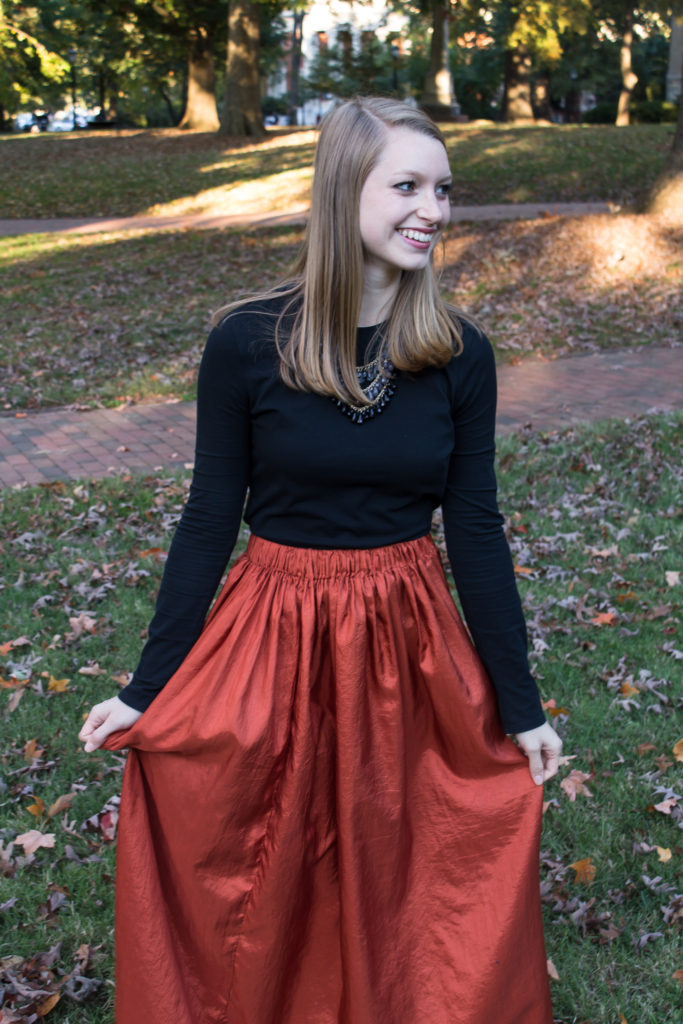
[108,537,552,1024]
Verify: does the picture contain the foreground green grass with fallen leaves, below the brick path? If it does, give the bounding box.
[0,415,683,1024]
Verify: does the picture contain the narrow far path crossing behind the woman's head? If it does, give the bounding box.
[0,203,613,236]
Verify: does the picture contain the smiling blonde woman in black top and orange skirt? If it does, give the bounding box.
[81,98,561,1024]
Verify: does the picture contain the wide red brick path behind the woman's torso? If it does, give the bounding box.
[0,346,683,486]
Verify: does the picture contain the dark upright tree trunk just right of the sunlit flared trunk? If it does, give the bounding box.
[221,0,265,138]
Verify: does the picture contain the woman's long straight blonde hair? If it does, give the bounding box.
[214,96,462,406]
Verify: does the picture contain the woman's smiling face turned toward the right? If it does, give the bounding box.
[359,128,452,278]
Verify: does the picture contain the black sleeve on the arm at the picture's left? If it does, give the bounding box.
[119,321,250,711]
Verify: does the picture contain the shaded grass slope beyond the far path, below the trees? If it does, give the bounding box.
[0,125,673,217]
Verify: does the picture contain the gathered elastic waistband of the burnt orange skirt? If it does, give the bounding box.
[245,534,438,579]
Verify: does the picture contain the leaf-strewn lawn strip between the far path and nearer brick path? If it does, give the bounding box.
[0,214,683,413]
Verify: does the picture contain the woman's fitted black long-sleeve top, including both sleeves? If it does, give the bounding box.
[120,299,545,732]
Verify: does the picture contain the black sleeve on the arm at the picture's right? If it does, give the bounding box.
[442,327,546,732]
